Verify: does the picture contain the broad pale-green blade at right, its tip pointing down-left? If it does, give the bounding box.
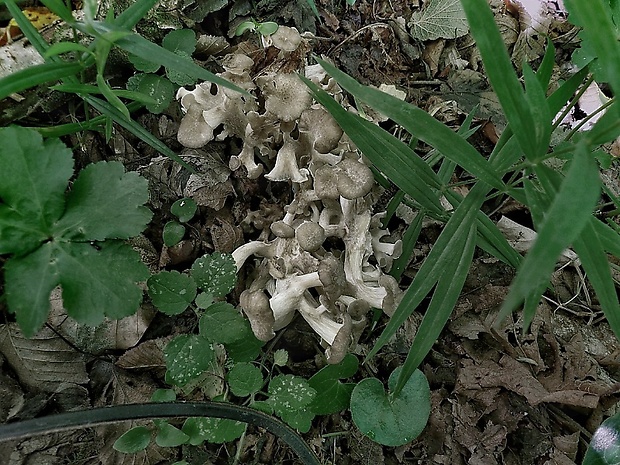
[498,144,601,327]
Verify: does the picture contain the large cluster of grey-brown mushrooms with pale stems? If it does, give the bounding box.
[177,27,402,363]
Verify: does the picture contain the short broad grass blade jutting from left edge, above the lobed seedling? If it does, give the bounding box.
[0,62,82,100]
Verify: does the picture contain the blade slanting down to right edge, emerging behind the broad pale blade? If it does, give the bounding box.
[573,218,620,340]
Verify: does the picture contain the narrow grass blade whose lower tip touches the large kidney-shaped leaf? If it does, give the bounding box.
[393,221,476,396]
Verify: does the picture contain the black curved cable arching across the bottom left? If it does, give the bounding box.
[0,402,321,465]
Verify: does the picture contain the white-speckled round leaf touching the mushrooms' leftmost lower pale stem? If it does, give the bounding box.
[190,252,237,297]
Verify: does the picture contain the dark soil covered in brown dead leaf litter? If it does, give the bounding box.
[0,0,620,465]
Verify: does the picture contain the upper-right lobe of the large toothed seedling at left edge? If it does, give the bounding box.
[54,161,153,241]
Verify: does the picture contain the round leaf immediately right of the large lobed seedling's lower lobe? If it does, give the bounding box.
[146,271,196,315]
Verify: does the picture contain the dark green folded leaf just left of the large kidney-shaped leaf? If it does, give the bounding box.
[308,354,359,415]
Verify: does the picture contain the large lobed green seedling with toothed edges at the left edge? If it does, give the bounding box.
[0,127,152,336]
